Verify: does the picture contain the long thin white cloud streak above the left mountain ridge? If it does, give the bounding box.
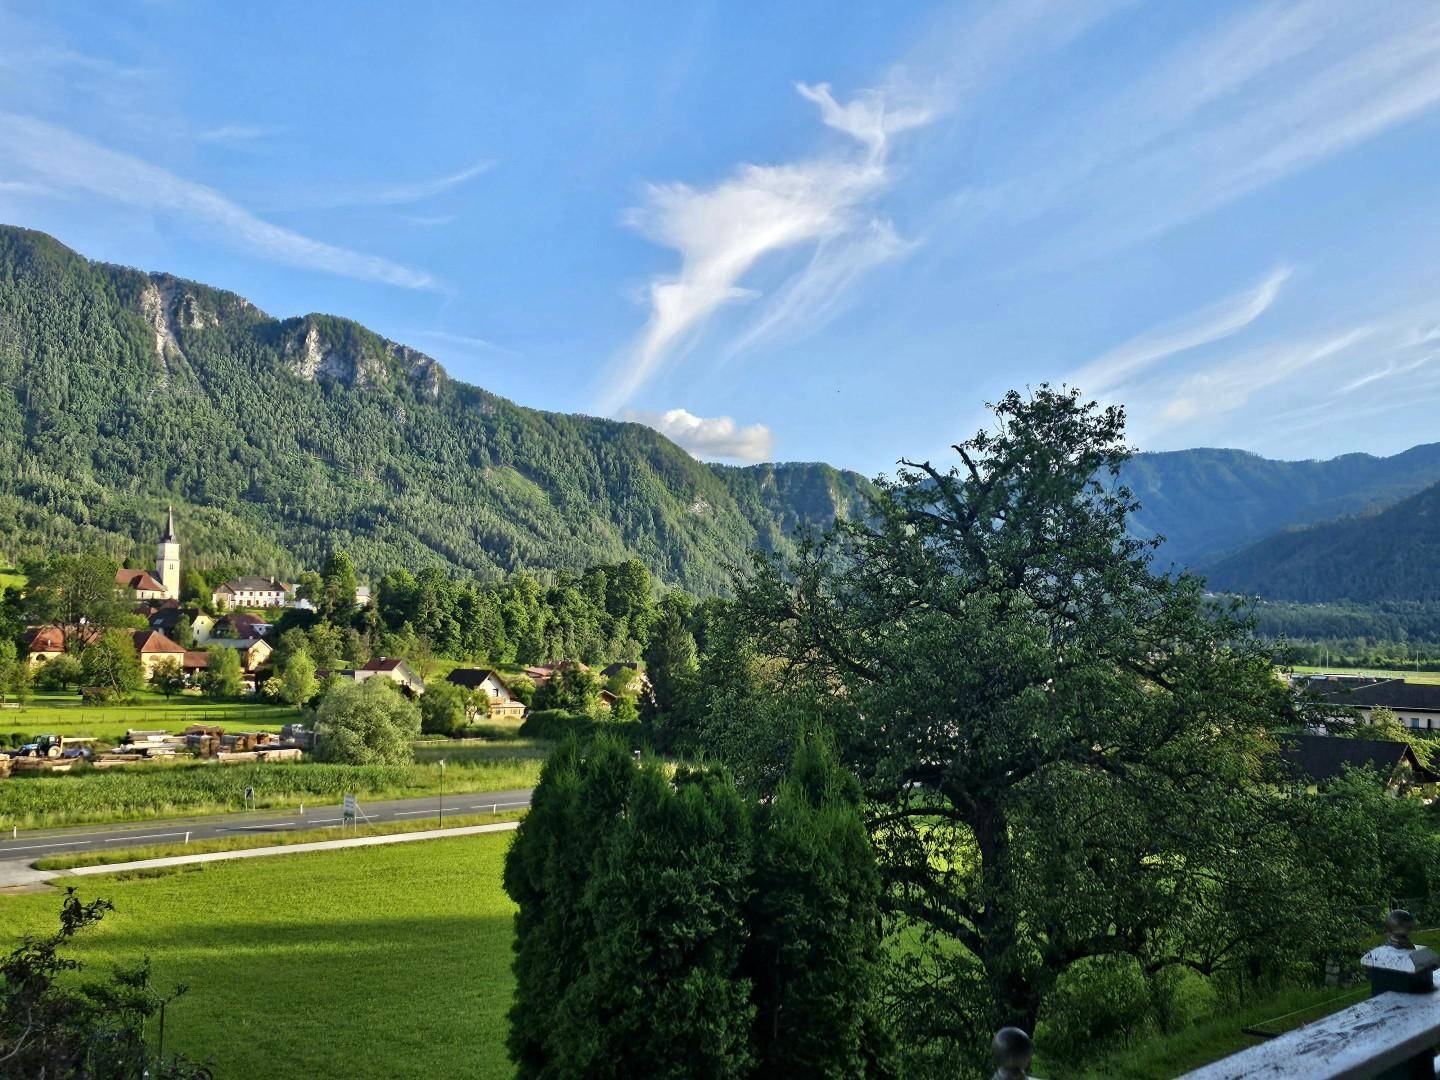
[0,112,436,289]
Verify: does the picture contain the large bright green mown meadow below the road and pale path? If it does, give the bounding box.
[0,832,514,1080]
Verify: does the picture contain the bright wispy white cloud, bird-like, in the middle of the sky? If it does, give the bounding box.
[600,85,930,413]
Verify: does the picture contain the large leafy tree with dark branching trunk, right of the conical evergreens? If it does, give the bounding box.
[734,387,1333,1071]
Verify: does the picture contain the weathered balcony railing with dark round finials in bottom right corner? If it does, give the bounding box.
[994,912,1440,1080]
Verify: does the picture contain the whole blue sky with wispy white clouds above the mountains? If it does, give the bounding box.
[0,0,1440,472]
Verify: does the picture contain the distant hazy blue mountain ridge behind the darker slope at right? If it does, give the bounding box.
[1123,444,1440,569]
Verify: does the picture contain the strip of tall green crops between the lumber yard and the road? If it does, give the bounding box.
[0,752,543,829]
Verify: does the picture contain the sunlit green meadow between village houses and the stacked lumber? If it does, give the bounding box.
[0,691,302,742]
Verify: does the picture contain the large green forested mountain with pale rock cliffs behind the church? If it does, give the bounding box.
[0,228,868,593]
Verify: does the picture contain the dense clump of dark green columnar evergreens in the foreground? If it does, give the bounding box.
[505,734,888,1077]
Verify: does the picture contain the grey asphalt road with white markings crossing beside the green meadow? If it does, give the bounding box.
[0,788,530,863]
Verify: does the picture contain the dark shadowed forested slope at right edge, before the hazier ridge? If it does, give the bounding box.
[1207,484,1440,603]
